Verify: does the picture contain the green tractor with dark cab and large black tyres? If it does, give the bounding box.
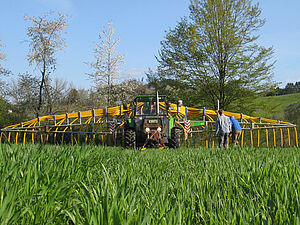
[124,94,182,149]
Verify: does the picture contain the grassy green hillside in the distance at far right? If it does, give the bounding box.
[254,93,300,120]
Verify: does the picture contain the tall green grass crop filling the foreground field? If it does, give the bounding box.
[0,144,300,224]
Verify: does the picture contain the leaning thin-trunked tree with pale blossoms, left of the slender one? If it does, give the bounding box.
[25,13,68,116]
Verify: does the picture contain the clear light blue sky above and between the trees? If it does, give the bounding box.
[0,0,300,89]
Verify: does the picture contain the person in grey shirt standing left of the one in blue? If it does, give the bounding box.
[215,109,231,148]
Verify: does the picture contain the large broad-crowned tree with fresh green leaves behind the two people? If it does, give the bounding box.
[148,0,274,108]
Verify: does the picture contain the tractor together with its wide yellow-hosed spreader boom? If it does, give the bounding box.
[0,93,298,149]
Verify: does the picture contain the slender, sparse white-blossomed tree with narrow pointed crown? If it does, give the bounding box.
[88,22,124,105]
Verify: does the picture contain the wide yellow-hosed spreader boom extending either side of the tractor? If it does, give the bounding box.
[0,103,299,148]
